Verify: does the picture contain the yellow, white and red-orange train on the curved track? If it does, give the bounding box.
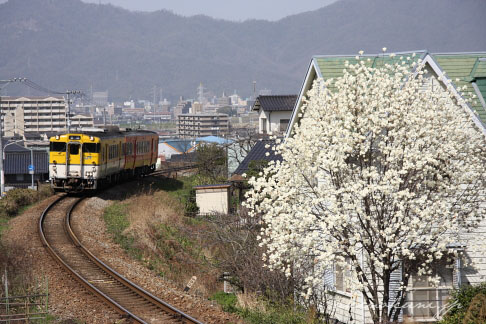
[49,130,158,191]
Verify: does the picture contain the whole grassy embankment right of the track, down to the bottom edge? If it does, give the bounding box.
[104,176,315,324]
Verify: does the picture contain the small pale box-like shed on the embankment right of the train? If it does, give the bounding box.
[194,184,231,215]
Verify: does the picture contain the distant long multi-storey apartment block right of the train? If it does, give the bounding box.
[177,114,229,138]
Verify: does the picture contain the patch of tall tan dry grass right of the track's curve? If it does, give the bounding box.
[109,191,222,297]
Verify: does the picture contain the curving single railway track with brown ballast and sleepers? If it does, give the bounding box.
[39,195,202,324]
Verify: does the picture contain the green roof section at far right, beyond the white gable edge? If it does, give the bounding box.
[432,53,486,123]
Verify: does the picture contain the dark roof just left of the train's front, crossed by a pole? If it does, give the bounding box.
[4,151,49,174]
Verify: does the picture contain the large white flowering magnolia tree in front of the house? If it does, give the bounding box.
[247,58,486,323]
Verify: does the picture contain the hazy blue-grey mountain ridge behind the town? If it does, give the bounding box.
[0,0,486,100]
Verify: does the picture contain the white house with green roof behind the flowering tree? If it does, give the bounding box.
[286,50,486,324]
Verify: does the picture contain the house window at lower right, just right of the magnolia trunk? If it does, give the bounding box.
[404,263,453,321]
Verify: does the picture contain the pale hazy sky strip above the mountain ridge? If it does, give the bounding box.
[80,0,336,21]
